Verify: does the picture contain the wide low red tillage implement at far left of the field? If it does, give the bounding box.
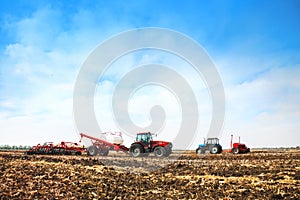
[25,142,86,155]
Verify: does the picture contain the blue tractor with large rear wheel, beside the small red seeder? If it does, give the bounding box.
[196,138,222,154]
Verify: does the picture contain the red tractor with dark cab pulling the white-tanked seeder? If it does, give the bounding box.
[129,132,173,157]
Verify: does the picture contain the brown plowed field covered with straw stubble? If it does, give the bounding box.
[0,150,300,199]
